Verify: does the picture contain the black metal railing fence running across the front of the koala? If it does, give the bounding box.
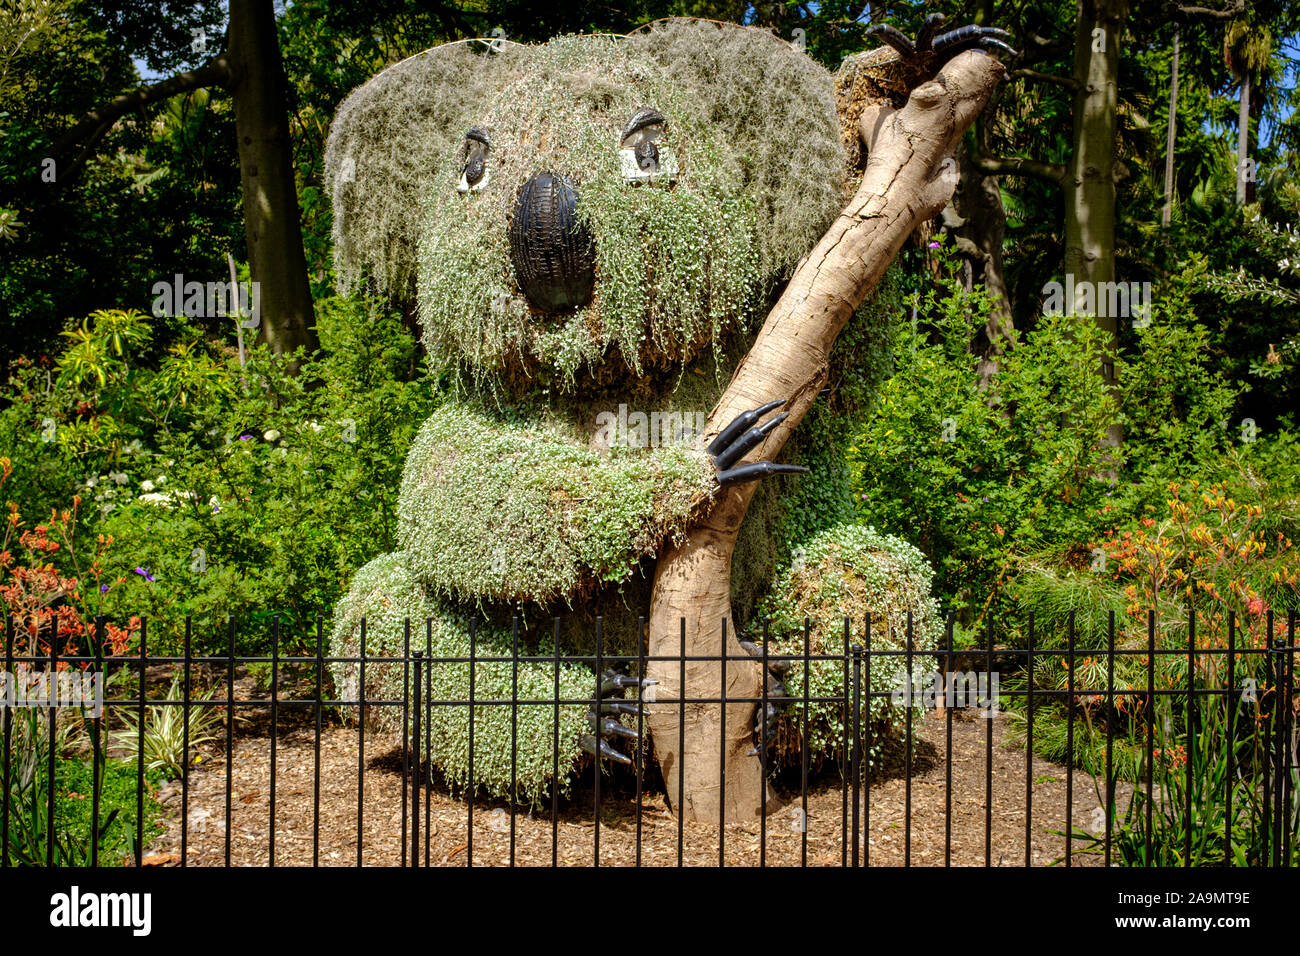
[0,611,1300,866]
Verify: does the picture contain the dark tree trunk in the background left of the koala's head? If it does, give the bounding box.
[228,0,319,355]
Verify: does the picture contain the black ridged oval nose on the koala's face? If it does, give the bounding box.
[510,173,595,312]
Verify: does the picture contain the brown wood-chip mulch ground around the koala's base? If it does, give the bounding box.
[139,671,1118,866]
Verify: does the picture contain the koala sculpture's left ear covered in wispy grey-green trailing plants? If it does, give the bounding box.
[325,42,524,300]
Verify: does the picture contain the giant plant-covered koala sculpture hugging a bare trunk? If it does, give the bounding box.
[326,18,1005,819]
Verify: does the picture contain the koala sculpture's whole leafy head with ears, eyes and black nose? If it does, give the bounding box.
[326,20,845,389]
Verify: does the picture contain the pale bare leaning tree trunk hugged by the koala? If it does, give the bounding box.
[649,51,1005,822]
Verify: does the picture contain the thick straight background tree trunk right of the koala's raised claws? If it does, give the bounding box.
[1065,0,1128,445]
